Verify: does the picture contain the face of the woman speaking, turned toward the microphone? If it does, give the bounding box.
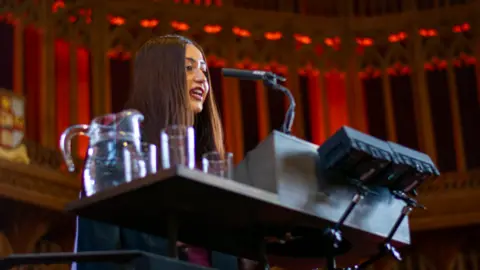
[185,44,210,113]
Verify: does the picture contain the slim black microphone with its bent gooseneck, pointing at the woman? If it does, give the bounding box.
[222,68,295,134]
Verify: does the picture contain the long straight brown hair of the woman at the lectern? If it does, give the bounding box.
[125,35,225,158]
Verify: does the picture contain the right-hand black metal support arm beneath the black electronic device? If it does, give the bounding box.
[344,191,425,270]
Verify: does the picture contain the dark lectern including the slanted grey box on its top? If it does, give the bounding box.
[0,132,410,270]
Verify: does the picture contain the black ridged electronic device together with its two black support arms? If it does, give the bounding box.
[318,126,440,270]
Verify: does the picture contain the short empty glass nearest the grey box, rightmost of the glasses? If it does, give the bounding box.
[202,152,233,179]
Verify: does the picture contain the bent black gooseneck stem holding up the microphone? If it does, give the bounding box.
[262,72,296,134]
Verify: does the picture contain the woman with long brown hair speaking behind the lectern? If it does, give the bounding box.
[73,35,254,270]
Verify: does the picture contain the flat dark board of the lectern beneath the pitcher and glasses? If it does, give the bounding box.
[66,166,408,264]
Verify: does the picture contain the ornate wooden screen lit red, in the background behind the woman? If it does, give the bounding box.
[0,0,480,269]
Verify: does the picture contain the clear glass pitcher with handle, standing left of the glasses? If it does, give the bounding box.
[60,110,146,196]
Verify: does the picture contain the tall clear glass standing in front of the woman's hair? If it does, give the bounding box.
[160,125,195,169]
